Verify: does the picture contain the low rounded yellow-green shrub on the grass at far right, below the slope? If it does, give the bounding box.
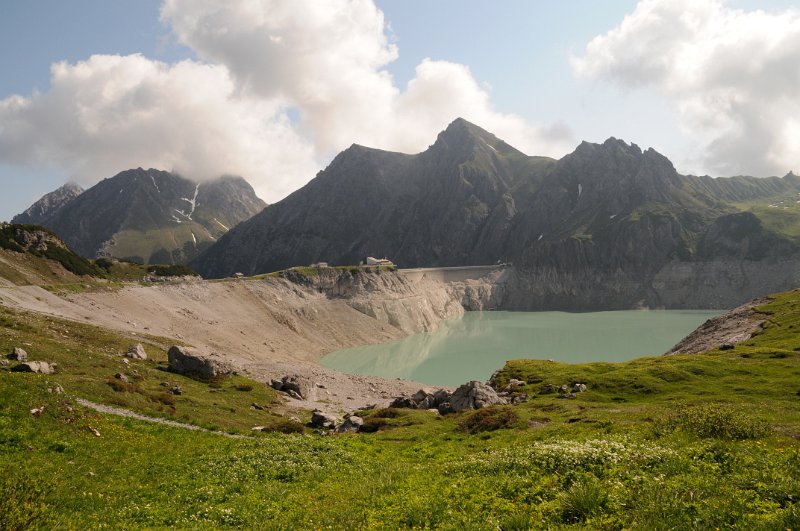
[668,404,769,440]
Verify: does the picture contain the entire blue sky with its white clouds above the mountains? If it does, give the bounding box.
[0,0,800,219]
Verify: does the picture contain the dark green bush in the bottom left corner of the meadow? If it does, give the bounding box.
[0,466,50,529]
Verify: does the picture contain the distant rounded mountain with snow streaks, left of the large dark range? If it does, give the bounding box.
[21,168,265,263]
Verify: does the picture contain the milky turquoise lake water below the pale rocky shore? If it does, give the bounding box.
[321,310,722,386]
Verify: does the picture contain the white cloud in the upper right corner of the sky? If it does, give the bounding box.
[572,0,800,179]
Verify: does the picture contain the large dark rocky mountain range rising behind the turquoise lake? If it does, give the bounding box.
[190,119,800,310]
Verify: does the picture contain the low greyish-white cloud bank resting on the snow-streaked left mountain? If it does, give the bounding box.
[0,55,316,203]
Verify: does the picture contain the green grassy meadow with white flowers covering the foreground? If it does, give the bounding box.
[0,292,800,530]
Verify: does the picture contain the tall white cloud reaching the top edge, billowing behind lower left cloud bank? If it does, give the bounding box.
[161,0,571,155]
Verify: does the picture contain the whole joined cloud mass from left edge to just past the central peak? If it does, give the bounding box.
[0,0,572,201]
